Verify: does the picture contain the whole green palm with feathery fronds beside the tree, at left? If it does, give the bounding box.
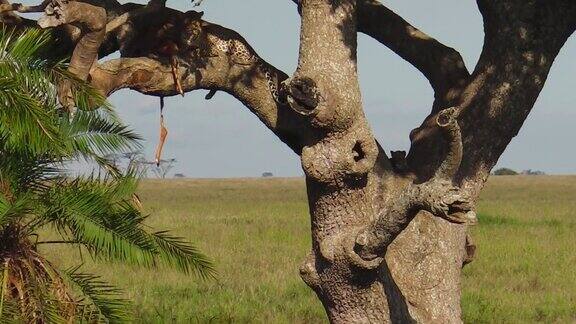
[0,30,213,323]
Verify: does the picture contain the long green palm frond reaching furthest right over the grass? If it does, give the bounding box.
[40,177,215,278]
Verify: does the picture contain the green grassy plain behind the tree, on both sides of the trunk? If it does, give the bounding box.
[41,176,576,323]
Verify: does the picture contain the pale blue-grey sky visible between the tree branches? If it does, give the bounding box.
[23,0,576,177]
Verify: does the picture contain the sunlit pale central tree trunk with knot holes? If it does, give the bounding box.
[289,0,465,323]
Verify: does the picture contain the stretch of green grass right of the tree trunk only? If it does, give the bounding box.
[462,176,576,323]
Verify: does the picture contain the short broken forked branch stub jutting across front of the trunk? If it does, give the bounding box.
[350,107,475,269]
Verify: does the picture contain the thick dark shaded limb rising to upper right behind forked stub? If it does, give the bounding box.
[408,0,576,190]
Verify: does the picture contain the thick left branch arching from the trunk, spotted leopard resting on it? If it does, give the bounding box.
[90,14,314,154]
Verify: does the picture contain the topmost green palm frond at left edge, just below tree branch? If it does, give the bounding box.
[0,30,61,154]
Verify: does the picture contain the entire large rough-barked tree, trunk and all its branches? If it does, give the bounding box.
[0,0,576,323]
